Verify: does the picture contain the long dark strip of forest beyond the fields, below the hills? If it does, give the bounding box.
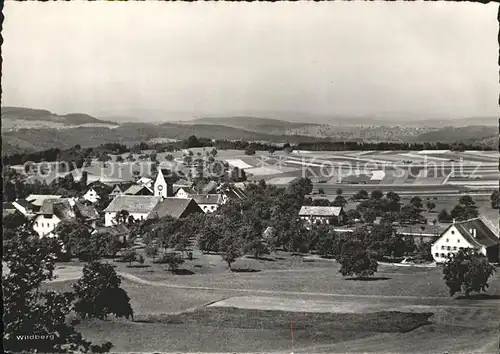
[2,135,494,168]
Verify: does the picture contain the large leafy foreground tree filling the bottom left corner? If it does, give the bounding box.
[2,228,112,353]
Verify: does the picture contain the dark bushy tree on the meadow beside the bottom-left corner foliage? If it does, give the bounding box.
[73,261,134,319]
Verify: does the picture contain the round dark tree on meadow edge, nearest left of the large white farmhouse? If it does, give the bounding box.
[338,239,378,278]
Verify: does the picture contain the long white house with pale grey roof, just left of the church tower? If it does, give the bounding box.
[104,195,162,226]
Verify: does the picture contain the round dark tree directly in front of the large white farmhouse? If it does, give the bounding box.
[443,248,495,297]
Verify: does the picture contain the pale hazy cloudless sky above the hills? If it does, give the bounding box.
[2,1,498,120]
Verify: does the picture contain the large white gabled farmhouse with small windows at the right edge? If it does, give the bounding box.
[431,218,500,263]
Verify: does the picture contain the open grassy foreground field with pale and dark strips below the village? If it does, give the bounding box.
[47,250,500,353]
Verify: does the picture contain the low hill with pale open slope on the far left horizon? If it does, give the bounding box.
[2,107,117,130]
